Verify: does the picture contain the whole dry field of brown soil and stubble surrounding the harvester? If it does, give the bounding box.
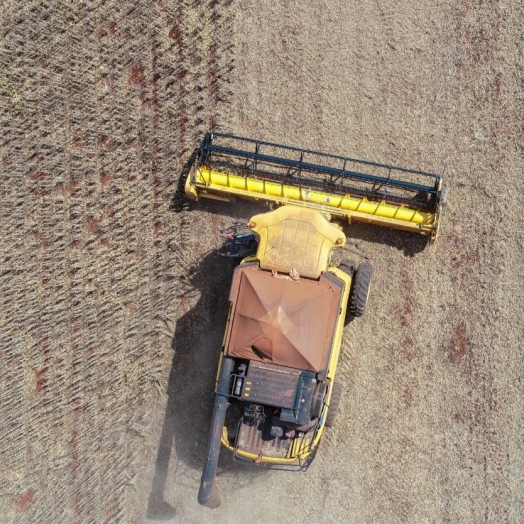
[0,0,524,524]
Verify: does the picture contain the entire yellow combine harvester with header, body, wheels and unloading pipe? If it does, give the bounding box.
[185,133,445,508]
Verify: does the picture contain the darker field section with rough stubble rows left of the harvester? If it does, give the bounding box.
[0,2,231,522]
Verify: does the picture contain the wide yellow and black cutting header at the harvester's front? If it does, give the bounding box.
[185,133,445,243]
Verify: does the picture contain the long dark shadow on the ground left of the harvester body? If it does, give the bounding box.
[147,253,266,520]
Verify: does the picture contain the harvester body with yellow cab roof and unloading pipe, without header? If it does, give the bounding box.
[199,206,353,507]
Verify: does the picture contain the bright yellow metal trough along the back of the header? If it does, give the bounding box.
[185,165,439,242]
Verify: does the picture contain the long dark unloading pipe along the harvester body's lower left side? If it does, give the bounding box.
[198,355,235,509]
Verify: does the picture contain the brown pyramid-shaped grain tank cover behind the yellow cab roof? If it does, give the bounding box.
[226,266,342,372]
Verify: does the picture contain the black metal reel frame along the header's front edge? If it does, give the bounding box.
[197,132,442,211]
